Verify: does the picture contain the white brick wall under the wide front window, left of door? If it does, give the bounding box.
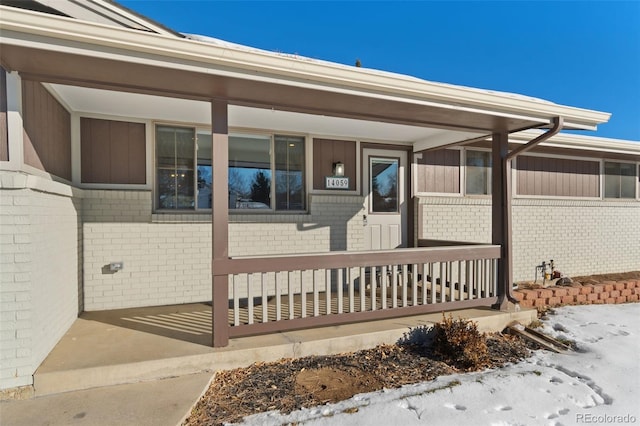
[83,191,363,311]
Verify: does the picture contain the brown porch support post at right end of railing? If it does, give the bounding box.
[491,132,513,310]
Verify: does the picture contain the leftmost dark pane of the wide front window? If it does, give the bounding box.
[156,126,195,209]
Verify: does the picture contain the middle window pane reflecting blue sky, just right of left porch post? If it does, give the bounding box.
[229,135,271,209]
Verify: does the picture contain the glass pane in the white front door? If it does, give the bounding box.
[369,157,399,213]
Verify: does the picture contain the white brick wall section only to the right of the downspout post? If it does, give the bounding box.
[513,199,640,281]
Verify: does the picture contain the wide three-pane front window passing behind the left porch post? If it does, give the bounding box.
[156,125,306,211]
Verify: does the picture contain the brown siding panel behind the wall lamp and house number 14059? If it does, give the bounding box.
[313,139,356,191]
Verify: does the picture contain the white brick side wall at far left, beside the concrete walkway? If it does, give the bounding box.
[0,172,79,388]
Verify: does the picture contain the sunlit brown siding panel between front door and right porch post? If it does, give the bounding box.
[417,149,460,194]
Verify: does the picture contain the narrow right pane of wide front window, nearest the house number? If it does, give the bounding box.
[274,136,305,210]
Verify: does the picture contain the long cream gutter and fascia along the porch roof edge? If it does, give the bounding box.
[0,6,610,130]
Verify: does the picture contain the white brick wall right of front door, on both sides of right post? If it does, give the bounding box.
[417,197,640,281]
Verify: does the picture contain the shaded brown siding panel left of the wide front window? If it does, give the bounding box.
[80,118,147,184]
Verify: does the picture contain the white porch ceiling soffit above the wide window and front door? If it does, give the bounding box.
[47,84,476,148]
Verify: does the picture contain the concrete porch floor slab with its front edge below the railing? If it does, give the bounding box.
[34,304,536,396]
